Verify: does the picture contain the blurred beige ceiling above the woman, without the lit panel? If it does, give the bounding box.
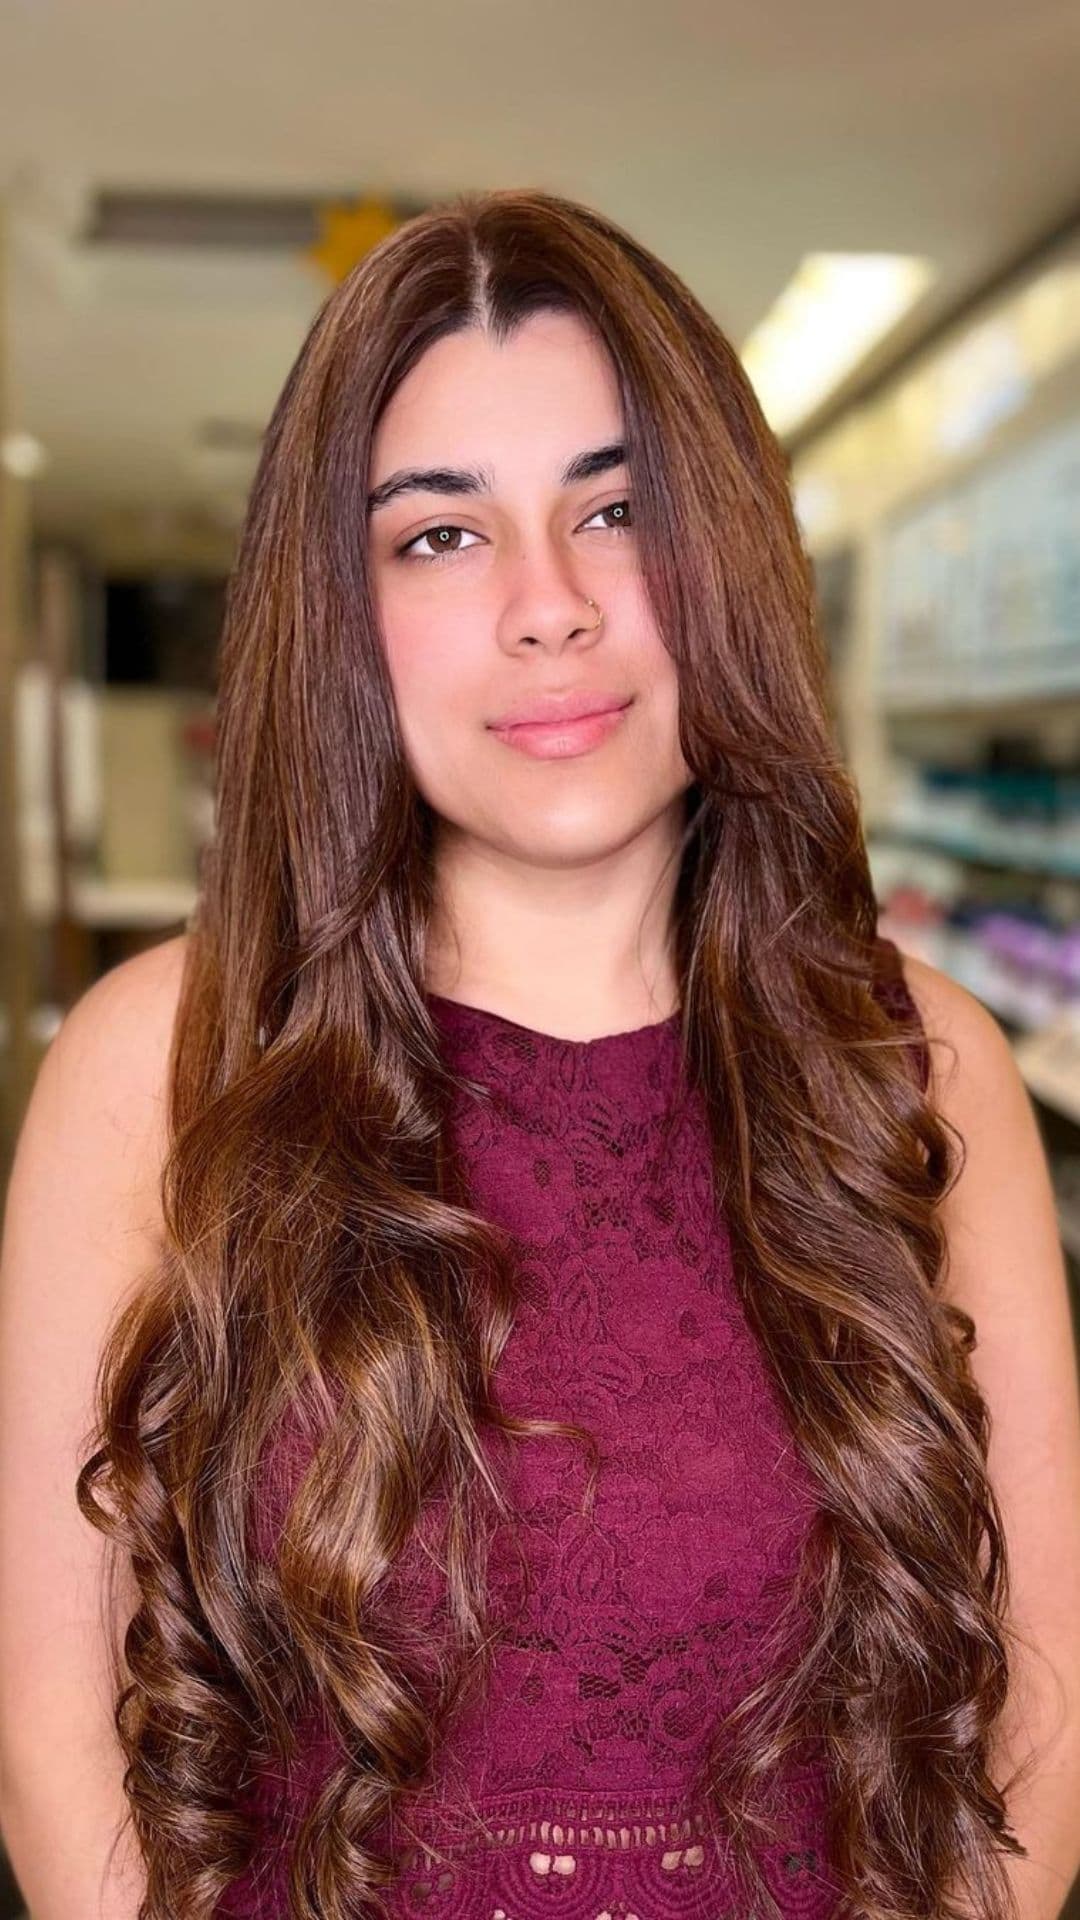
[0,0,1080,560]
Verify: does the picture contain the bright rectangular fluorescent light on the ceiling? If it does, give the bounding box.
[740,253,936,434]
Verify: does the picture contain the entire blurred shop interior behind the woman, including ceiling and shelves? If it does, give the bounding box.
[0,0,1080,1916]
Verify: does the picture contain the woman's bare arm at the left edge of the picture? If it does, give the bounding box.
[0,937,184,1920]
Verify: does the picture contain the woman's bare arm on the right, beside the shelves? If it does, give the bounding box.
[903,954,1080,1920]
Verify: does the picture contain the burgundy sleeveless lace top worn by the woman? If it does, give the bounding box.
[217,935,928,1920]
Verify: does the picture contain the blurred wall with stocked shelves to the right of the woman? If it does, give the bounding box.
[794,236,1080,1351]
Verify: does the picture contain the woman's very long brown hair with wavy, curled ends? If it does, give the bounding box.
[77,190,1026,1920]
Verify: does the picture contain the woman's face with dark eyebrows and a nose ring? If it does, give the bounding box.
[367,311,692,862]
